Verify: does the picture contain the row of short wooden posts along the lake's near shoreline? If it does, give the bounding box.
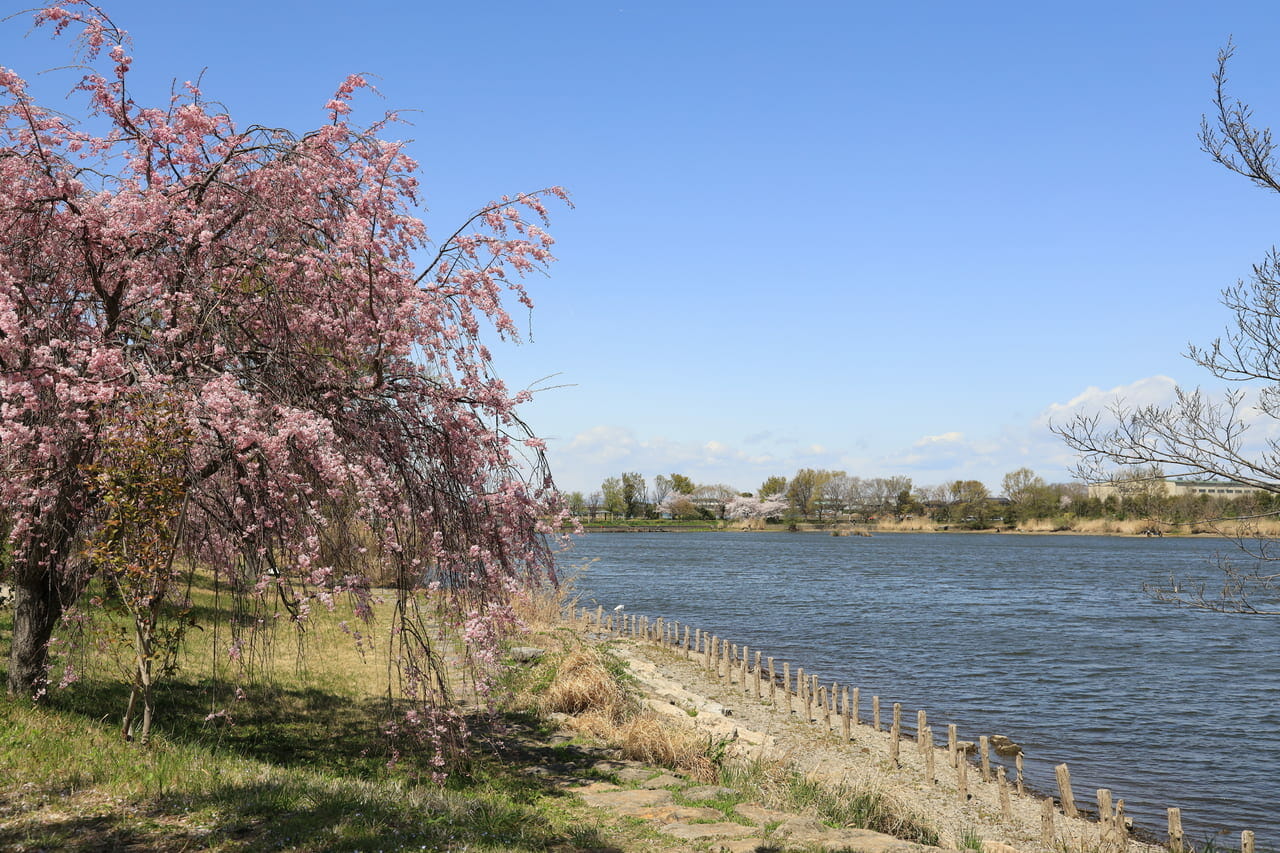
[572,607,1254,853]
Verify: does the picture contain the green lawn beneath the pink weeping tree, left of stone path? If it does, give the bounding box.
[0,578,640,850]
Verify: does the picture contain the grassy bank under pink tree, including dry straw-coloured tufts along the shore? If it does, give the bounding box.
[0,571,932,852]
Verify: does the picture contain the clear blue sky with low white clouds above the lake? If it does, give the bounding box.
[10,0,1280,491]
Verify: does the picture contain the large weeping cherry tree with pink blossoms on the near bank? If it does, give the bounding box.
[0,0,564,721]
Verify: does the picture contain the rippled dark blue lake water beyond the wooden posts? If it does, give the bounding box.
[561,533,1280,850]
